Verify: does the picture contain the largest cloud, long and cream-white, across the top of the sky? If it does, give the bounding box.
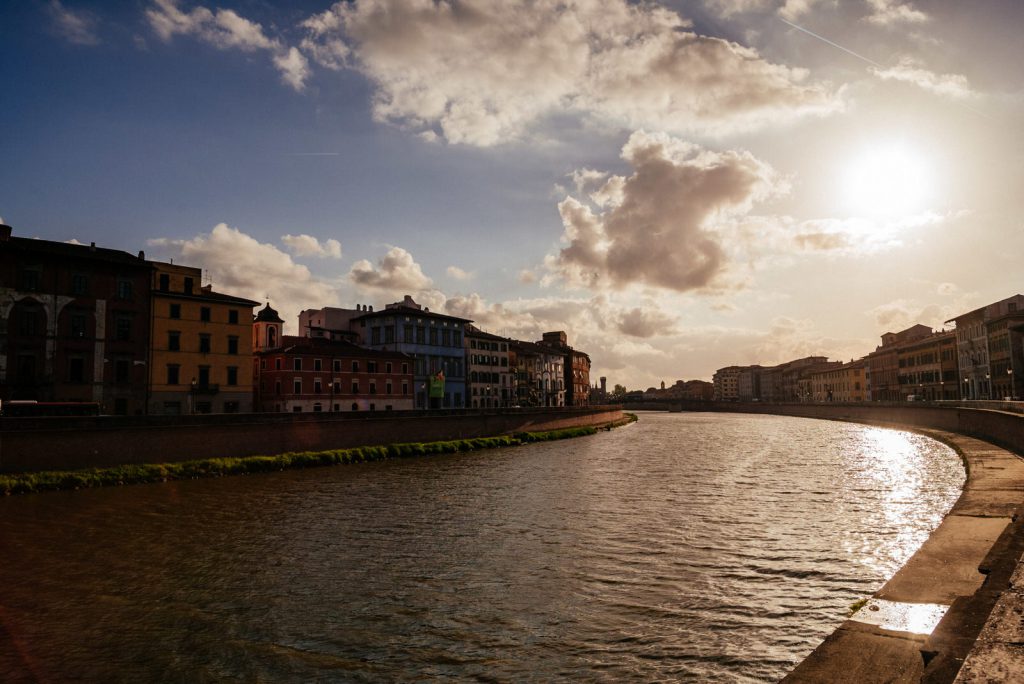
[301,0,839,146]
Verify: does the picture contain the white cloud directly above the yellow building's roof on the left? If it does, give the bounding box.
[147,223,339,328]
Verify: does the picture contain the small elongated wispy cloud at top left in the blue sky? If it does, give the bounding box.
[145,0,309,91]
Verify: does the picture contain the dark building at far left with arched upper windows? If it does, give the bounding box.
[0,225,152,415]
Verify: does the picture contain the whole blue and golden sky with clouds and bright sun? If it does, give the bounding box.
[0,0,1024,389]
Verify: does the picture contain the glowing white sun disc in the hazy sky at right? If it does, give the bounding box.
[841,143,932,217]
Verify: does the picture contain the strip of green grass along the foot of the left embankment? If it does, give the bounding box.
[0,414,636,495]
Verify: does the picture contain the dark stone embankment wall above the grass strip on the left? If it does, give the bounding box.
[0,405,624,473]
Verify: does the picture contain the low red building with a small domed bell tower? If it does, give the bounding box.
[253,304,414,413]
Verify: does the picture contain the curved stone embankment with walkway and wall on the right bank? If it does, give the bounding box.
[675,404,1024,684]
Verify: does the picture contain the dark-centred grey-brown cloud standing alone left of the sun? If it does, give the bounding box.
[546,131,785,292]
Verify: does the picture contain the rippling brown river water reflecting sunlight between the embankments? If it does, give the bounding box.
[0,414,964,682]
